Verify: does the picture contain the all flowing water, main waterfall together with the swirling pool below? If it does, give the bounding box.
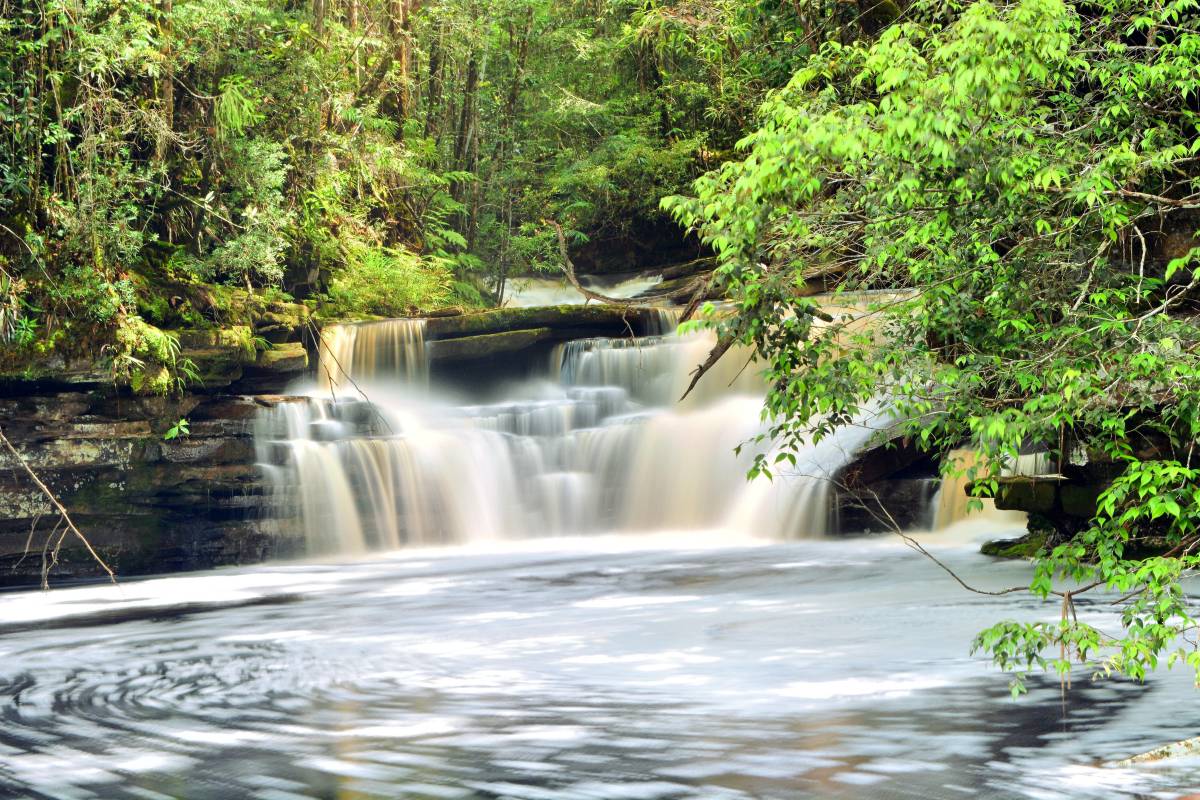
[0,309,1200,800]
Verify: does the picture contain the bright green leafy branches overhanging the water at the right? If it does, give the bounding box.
[665,0,1200,690]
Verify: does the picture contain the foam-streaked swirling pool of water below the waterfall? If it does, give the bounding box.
[0,528,1200,800]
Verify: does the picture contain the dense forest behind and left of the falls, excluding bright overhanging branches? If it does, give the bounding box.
[0,0,883,389]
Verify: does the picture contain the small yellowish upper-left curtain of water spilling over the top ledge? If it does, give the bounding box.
[317,319,430,391]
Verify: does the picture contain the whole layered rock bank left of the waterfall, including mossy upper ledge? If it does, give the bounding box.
[0,303,308,585]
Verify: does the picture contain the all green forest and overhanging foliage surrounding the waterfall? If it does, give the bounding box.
[7,0,1200,690]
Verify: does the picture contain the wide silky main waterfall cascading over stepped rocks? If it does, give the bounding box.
[256,313,888,553]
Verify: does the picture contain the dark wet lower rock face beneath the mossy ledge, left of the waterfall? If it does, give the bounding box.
[0,386,299,585]
